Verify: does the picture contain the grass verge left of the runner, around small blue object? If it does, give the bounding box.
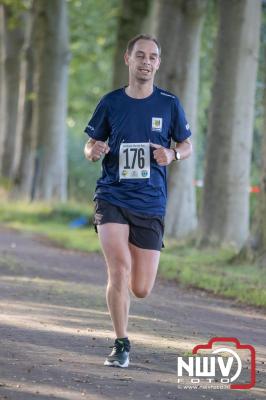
[0,203,100,252]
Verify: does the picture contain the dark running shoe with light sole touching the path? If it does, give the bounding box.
[104,339,130,368]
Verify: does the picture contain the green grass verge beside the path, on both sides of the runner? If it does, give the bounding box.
[0,202,266,307]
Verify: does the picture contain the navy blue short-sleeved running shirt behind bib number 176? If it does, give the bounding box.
[85,87,191,216]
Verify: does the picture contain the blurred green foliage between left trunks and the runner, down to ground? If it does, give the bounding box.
[67,0,120,200]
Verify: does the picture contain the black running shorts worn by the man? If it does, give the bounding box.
[94,199,164,251]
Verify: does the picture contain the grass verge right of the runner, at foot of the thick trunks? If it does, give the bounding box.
[160,245,266,307]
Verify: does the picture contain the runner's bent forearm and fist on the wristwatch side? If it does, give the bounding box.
[150,138,192,166]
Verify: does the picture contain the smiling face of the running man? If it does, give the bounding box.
[125,39,161,83]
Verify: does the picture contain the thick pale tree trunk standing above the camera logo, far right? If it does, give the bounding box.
[201,0,261,247]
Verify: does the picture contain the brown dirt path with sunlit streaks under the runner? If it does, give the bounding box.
[0,228,266,400]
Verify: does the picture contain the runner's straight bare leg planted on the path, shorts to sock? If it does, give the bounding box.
[97,223,131,338]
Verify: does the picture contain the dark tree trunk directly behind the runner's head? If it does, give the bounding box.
[113,0,151,89]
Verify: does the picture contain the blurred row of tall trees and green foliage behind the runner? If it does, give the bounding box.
[0,0,266,258]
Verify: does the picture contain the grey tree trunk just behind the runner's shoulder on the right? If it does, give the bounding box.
[157,0,206,239]
